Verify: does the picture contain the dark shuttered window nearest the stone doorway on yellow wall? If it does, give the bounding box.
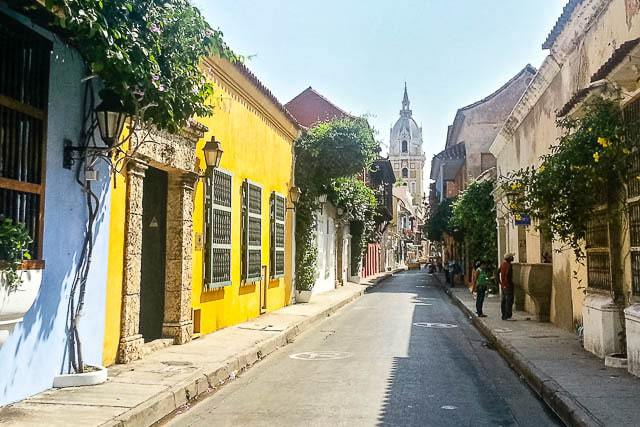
[204,169,232,291]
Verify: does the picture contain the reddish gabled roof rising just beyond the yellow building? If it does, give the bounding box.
[285,86,353,128]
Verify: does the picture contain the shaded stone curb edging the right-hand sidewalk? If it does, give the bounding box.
[434,276,605,427]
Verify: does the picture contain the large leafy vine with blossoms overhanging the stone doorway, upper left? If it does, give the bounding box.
[46,0,238,132]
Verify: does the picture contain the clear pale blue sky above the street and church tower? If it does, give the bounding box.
[194,0,567,176]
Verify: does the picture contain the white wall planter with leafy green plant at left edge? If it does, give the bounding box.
[0,215,42,347]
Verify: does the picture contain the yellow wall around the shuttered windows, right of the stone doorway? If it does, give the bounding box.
[192,58,299,334]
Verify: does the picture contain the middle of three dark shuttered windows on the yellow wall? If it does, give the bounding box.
[242,180,262,283]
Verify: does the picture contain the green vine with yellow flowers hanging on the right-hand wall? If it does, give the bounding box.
[502,98,640,259]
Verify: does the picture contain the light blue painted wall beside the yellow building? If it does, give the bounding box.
[0,8,110,405]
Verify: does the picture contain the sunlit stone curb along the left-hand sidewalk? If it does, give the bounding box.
[101,269,403,427]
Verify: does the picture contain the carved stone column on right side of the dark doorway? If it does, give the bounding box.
[162,173,198,344]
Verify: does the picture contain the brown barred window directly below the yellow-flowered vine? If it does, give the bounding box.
[586,213,613,290]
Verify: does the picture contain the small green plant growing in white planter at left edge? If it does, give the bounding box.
[0,216,33,292]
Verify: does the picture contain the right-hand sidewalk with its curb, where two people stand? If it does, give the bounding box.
[436,276,640,427]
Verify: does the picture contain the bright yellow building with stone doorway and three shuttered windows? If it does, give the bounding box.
[103,58,300,365]
